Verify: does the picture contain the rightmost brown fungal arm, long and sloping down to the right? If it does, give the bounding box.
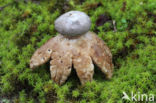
[91,34,113,78]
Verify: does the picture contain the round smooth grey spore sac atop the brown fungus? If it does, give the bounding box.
[55,11,91,36]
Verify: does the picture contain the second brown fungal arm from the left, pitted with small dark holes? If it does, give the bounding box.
[50,50,72,85]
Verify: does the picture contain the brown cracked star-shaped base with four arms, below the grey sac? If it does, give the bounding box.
[30,31,113,85]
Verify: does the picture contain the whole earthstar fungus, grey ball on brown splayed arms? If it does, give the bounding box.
[30,11,113,85]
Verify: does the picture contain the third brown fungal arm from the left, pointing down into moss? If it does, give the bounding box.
[73,52,94,85]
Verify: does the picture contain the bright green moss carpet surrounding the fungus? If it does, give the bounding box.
[0,0,156,103]
